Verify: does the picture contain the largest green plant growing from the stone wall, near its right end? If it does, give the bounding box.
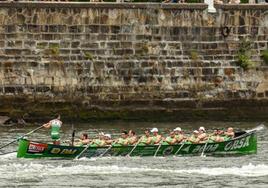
[236,39,255,70]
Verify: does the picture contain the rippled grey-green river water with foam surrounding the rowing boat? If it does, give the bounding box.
[0,122,268,188]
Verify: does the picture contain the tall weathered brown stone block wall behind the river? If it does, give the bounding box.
[0,2,268,120]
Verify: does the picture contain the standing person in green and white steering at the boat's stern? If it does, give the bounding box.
[43,115,62,145]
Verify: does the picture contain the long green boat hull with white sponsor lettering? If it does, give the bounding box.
[17,131,257,158]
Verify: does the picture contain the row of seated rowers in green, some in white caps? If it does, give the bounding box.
[75,127,235,147]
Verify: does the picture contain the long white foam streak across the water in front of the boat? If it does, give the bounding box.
[0,163,268,178]
